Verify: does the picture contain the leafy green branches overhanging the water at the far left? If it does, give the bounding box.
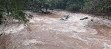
[0,0,28,22]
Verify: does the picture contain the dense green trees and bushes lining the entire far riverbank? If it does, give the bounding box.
[0,0,111,23]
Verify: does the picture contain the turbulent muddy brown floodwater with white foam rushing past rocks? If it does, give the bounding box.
[0,10,111,49]
